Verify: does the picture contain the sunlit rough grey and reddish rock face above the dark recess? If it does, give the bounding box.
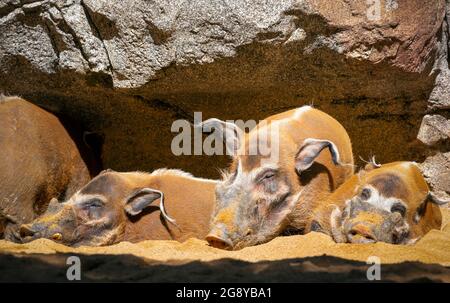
[1,0,444,88]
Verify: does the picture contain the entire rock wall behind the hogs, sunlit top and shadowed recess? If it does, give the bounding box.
[0,0,450,197]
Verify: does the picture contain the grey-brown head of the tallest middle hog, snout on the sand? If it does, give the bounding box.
[200,119,340,250]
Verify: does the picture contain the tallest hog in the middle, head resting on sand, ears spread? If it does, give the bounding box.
[201,106,353,249]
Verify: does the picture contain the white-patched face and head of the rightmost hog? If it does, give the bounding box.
[330,172,448,244]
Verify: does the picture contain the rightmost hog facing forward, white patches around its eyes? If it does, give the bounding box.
[310,162,448,244]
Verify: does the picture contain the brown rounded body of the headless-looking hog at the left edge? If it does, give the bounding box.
[0,96,90,238]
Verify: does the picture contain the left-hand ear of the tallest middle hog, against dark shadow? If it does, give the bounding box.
[195,118,242,156]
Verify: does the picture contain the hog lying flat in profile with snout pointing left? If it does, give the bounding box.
[20,169,216,246]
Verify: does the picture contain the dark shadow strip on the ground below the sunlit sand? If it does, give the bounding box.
[0,254,450,283]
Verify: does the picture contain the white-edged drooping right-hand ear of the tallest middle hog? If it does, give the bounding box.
[295,138,341,173]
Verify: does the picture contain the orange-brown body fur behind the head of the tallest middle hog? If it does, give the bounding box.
[237,108,353,230]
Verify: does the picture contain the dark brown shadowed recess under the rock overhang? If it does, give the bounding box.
[0,38,435,178]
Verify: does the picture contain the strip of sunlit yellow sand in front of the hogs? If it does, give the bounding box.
[0,209,450,266]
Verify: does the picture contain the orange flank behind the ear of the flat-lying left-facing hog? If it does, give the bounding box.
[123,171,216,242]
